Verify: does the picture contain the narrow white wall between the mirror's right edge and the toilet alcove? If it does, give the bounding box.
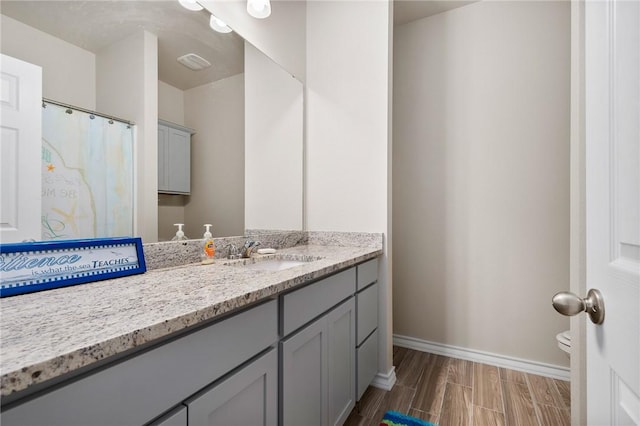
[305,1,392,374]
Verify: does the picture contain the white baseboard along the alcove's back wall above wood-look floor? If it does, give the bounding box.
[393,334,571,381]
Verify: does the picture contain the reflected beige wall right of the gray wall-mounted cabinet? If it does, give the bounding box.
[184,74,245,238]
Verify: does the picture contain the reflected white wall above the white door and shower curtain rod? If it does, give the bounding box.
[0,15,96,110]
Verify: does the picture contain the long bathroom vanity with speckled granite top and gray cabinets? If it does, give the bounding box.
[0,238,382,426]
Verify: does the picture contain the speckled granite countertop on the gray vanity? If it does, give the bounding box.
[0,234,382,397]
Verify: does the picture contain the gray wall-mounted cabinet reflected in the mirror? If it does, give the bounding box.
[158,120,195,194]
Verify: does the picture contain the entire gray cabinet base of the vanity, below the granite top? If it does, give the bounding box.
[1,260,378,426]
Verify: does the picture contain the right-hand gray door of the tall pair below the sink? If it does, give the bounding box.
[326,297,356,425]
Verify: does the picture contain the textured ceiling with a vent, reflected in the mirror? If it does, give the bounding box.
[0,0,244,90]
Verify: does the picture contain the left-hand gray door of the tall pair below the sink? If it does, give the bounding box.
[280,317,327,426]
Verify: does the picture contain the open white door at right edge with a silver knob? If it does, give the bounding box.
[585,0,640,426]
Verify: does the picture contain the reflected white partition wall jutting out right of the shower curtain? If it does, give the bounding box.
[96,31,158,242]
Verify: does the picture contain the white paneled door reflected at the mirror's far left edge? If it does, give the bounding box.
[0,55,42,243]
